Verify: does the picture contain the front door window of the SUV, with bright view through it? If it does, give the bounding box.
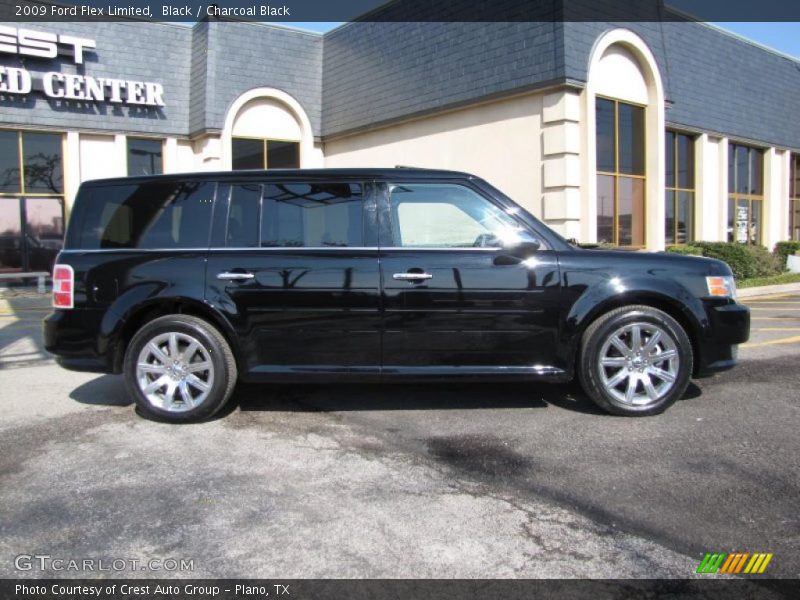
[389,183,520,248]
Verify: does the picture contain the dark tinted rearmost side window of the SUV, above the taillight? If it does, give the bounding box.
[68,182,214,249]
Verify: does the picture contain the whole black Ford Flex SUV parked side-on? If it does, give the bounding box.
[44,169,750,421]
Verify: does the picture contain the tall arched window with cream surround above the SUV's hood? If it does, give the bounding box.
[583,29,666,249]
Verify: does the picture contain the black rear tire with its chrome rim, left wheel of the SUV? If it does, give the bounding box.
[123,314,238,423]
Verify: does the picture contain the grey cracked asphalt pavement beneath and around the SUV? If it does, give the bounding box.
[0,292,800,578]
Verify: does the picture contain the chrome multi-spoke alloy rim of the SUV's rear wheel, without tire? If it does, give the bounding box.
[136,331,214,412]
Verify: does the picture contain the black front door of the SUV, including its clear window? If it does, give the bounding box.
[379,182,560,376]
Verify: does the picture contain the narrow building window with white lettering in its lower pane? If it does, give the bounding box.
[728,143,764,244]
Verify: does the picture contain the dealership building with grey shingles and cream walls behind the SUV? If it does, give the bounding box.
[0,2,800,270]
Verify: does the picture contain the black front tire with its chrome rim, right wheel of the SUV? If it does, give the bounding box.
[577,305,694,417]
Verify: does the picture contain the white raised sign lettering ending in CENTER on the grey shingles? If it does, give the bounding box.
[0,25,165,106]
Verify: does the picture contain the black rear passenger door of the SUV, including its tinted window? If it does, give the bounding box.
[206,180,380,380]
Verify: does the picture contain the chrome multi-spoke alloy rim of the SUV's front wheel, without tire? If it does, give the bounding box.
[598,322,680,407]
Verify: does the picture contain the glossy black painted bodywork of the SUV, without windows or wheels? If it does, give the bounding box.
[44,169,749,381]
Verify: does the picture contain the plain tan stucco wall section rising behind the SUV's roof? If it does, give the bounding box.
[324,94,543,216]
